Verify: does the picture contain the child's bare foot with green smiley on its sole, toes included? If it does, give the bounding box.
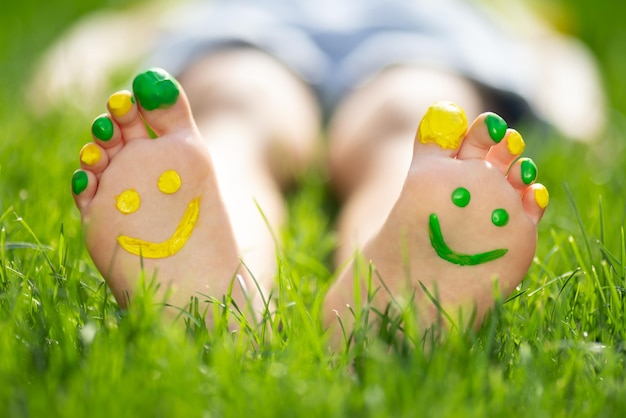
[326,102,548,334]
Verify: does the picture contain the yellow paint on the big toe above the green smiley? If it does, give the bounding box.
[417,102,467,150]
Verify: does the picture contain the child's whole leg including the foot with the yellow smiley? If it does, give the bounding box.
[72,50,318,319]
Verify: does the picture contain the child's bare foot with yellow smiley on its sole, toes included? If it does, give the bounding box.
[72,70,254,311]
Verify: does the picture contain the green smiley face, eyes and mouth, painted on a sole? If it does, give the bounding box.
[428,187,509,266]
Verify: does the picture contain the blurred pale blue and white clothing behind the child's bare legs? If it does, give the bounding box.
[148,0,536,118]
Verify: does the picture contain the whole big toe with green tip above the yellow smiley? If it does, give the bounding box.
[133,68,195,136]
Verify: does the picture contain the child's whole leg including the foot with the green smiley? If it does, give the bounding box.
[326,68,548,334]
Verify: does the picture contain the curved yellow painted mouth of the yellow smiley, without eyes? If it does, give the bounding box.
[117,196,202,258]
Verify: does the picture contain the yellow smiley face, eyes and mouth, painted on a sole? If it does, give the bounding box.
[116,170,201,258]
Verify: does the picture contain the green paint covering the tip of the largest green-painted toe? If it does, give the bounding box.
[133,68,180,110]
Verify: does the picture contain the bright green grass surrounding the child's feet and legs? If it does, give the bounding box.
[0,0,626,417]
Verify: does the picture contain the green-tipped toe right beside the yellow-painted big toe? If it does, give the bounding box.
[457,112,508,160]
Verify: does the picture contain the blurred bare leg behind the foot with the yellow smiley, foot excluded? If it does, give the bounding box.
[179,48,320,288]
